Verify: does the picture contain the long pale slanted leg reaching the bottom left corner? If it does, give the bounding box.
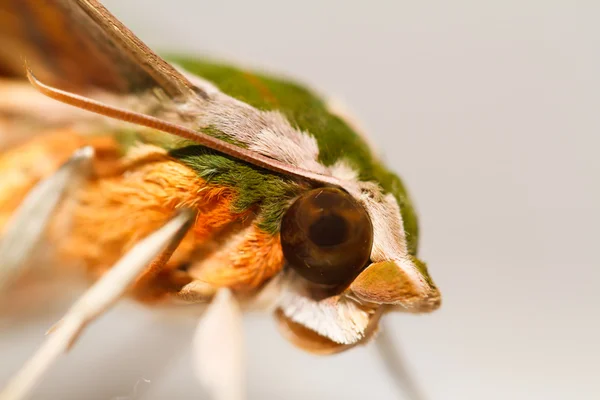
[0,210,195,400]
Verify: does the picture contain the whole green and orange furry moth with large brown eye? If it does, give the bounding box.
[0,0,441,399]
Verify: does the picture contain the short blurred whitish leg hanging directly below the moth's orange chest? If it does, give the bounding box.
[193,288,245,400]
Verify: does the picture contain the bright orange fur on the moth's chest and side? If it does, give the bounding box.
[0,130,283,300]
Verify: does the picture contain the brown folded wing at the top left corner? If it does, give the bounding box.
[0,0,201,101]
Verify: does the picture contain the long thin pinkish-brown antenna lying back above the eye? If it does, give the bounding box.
[25,64,340,186]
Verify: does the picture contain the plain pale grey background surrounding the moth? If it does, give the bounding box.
[0,0,600,400]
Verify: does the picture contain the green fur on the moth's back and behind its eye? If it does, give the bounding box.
[170,57,418,254]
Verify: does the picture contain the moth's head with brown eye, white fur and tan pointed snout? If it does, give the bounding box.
[276,175,440,354]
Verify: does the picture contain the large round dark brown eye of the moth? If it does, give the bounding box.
[281,188,373,285]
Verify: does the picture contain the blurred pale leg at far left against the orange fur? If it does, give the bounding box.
[0,146,94,292]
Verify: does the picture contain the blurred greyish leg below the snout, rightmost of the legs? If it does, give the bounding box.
[375,325,426,400]
